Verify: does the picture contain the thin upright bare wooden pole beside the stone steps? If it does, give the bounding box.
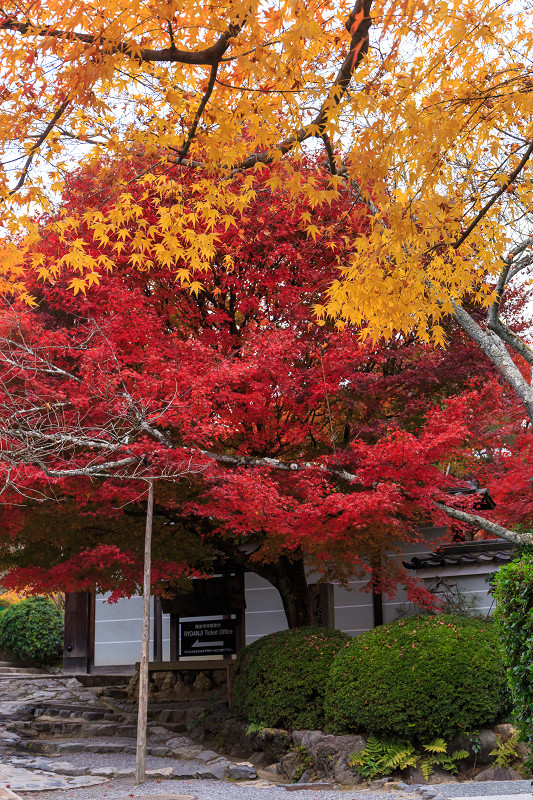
[135,480,154,783]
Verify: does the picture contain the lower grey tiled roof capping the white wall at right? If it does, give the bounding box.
[402,539,516,570]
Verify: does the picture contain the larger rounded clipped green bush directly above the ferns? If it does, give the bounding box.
[325,614,508,743]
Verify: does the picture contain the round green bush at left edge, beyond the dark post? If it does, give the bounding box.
[0,597,63,664]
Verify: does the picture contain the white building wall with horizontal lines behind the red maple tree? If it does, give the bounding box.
[89,528,494,667]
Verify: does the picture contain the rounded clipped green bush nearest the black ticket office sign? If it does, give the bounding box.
[233,628,350,730]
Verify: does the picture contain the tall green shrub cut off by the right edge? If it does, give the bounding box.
[492,551,533,771]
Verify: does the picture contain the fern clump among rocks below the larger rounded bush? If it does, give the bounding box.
[349,736,468,780]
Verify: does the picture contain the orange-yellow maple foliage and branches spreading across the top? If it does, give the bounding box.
[0,0,533,341]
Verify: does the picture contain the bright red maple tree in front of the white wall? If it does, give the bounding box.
[0,163,508,625]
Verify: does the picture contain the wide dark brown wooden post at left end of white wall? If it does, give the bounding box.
[63,592,94,674]
